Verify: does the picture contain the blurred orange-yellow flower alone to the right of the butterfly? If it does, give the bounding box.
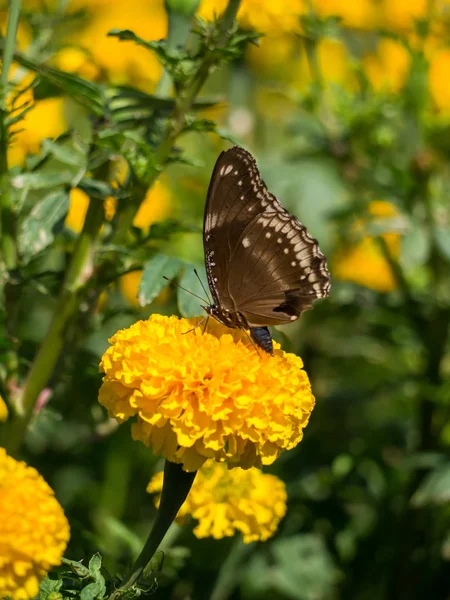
[332,200,401,292]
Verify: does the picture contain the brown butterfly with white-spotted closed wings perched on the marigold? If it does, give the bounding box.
[202,146,330,354]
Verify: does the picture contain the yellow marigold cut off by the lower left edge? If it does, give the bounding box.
[0,448,69,600]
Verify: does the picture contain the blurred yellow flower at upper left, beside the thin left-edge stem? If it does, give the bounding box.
[8,98,67,166]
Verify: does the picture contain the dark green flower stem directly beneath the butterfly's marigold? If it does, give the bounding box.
[109,460,197,600]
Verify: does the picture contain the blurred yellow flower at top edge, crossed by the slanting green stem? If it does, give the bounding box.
[198,0,305,34]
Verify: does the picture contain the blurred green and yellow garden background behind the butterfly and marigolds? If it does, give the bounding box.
[0,0,450,600]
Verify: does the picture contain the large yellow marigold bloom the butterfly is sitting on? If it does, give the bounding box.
[99,315,315,471]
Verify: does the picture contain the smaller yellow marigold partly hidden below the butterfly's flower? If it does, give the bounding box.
[147,460,287,544]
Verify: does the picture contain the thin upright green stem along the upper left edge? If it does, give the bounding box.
[0,0,20,271]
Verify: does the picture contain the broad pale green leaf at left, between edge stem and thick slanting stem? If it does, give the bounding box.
[19,189,69,261]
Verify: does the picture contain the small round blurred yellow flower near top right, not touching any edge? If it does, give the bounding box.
[364,39,411,92]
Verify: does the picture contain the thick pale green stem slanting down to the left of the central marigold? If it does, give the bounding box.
[5,199,104,454]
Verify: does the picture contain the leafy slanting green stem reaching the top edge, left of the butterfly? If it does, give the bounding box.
[114,0,241,244]
